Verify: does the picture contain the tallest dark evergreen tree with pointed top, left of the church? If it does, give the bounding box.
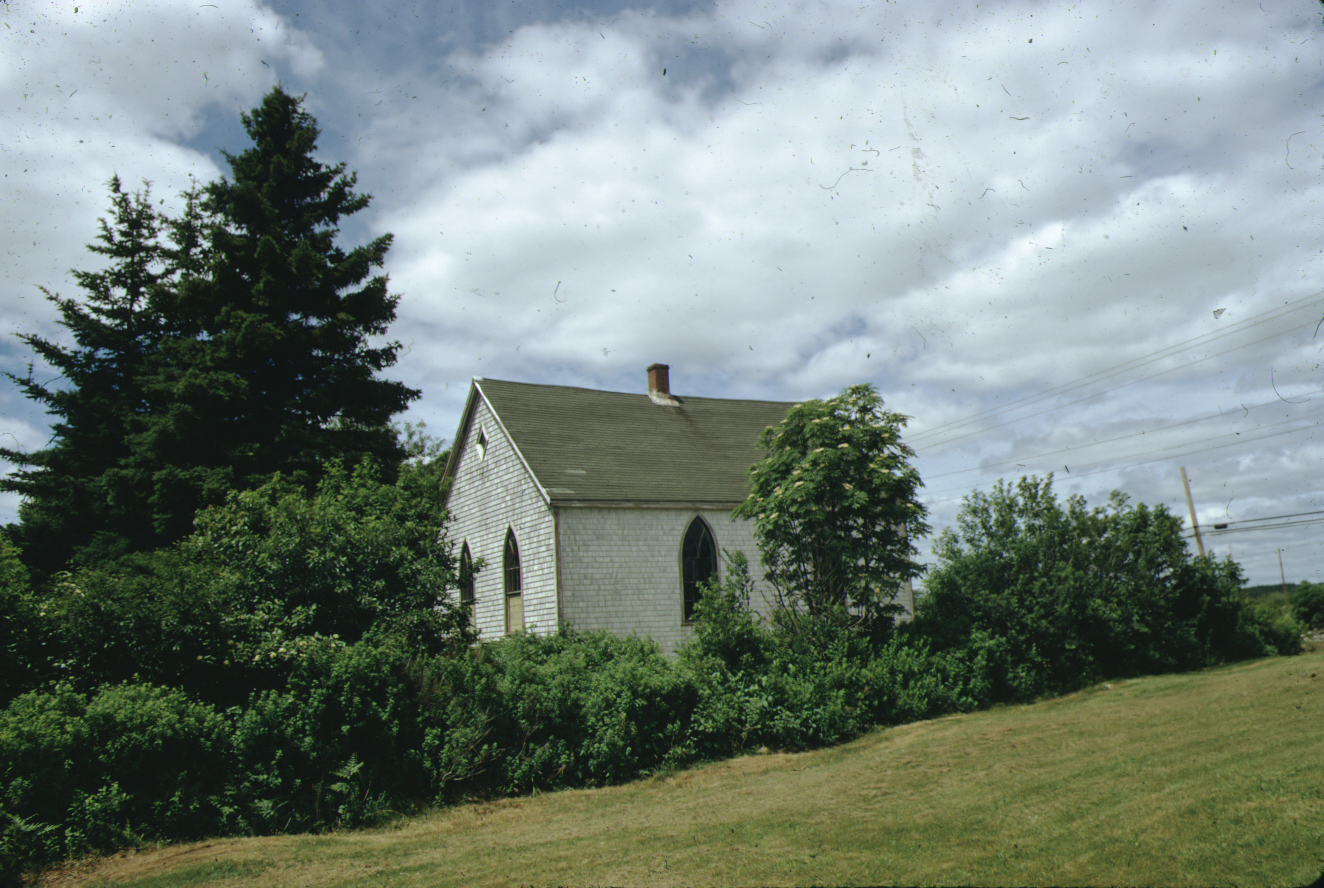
[131,86,418,539]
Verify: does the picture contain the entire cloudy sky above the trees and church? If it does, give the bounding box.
[0,0,1324,582]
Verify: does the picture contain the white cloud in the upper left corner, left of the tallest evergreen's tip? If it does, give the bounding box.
[0,0,322,335]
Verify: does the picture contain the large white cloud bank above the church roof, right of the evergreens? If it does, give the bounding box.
[365,4,1324,582]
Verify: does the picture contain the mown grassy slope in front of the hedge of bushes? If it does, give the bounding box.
[50,652,1324,887]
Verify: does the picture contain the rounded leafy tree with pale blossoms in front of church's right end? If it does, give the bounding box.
[733,385,928,627]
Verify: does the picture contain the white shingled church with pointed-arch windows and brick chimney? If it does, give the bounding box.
[445,364,793,651]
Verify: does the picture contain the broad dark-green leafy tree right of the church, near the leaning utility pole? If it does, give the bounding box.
[912,475,1291,700]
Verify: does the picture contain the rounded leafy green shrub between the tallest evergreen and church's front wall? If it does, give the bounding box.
[181,462,470,652]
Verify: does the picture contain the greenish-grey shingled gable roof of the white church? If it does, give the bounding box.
[445,378,794,506]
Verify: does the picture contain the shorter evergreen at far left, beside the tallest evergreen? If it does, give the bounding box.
[0,177,179,573]
